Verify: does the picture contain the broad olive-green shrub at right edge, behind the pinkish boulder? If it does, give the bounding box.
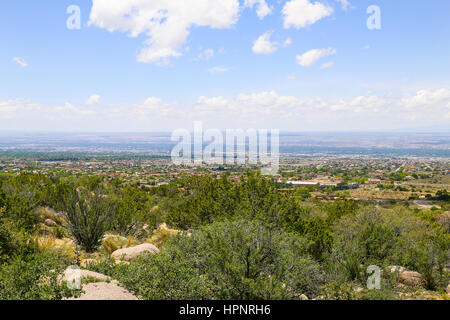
[331,207,450,289]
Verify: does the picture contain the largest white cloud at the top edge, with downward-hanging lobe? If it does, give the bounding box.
[89,0,239,65]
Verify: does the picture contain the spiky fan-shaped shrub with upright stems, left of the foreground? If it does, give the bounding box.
[60,188,115,252]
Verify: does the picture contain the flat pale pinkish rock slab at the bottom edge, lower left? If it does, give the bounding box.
[68,282,139,300]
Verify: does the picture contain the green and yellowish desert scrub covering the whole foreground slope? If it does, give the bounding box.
[0,172,450,299]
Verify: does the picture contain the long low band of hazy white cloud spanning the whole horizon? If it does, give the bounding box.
[0,88,450,131]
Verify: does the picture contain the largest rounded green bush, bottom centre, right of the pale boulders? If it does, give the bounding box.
[90,220,323,300]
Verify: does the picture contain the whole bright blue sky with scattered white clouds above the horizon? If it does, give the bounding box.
[0,0,450,131]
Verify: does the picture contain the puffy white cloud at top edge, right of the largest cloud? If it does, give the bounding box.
[282,0,334,29]
